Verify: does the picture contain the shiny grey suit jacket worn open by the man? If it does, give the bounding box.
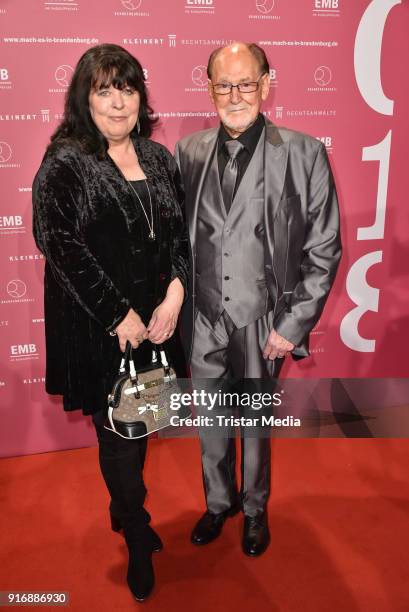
[176,119,341,358]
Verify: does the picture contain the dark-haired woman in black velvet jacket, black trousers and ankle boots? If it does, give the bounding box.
[33,44,187,600]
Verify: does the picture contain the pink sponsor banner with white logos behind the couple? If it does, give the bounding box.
[0,0,409,456]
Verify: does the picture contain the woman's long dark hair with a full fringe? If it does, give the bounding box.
[50,44,157,159]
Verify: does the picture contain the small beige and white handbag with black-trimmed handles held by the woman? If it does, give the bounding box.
[104,341,191,440]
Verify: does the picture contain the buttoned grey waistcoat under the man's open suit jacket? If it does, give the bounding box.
[196,130,269,327]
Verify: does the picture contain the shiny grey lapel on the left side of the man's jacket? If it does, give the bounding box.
[188,128,218,253]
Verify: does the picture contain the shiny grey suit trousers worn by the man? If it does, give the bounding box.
[191,311,283,516]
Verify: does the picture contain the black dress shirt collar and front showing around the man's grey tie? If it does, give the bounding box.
[217,113,265,195]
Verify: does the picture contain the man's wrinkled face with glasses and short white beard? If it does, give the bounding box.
[209,45,270,138]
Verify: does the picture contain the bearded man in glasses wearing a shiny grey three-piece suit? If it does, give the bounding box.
[176,43,341,556]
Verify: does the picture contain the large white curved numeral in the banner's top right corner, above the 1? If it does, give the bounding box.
[354,0,402,115]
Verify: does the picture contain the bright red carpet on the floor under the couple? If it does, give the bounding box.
[0,439,409,612]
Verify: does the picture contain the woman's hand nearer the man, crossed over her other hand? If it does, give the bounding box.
[148,278,184,344]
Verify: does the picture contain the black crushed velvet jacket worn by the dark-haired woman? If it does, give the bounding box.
[33,133,188,414]
